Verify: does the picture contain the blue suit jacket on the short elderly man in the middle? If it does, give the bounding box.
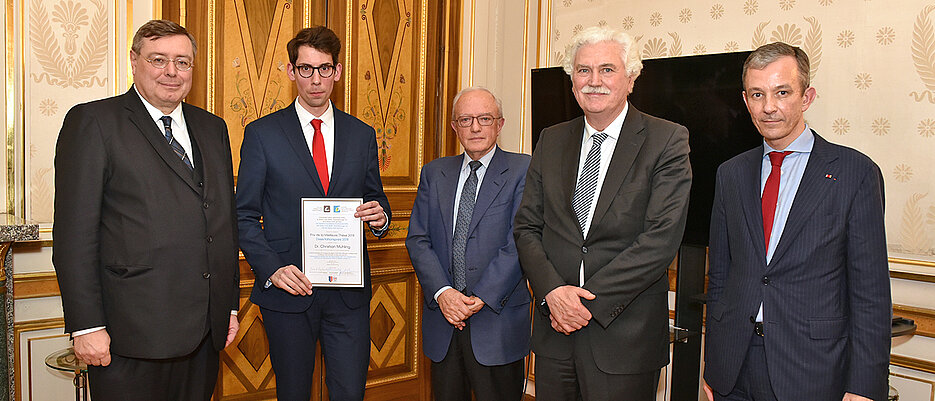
[406,149,530,366]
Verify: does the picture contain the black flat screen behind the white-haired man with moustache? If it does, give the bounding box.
[531,52,761,246]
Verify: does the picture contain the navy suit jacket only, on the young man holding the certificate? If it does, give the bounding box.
[237,102,390,312]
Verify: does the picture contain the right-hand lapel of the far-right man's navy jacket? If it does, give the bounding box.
[770,131,838,266]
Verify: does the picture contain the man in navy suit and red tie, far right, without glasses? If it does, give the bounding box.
[704,42,892,401]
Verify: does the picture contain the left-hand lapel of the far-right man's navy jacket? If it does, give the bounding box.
[738,144,766,263]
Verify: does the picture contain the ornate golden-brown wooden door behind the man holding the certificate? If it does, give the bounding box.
[162,0,461,400]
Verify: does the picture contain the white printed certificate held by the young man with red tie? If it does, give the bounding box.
[302,198,364,288]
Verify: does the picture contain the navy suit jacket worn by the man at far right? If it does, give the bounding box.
[704,134,892,401]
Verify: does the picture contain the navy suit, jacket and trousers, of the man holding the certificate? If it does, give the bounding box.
[237,103,390,400]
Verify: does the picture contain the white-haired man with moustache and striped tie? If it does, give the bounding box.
[515,27,691,400]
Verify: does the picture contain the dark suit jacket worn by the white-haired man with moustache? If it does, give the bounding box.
[515,105,691,374]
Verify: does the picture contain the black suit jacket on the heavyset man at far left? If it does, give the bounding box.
[52,88,240,358]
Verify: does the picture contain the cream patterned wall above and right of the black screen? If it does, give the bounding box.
[540,0,935,268]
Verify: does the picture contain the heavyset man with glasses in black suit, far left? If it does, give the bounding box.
[52,20,240,400]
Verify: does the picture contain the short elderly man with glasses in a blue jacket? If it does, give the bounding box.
[406,87,529,401]
